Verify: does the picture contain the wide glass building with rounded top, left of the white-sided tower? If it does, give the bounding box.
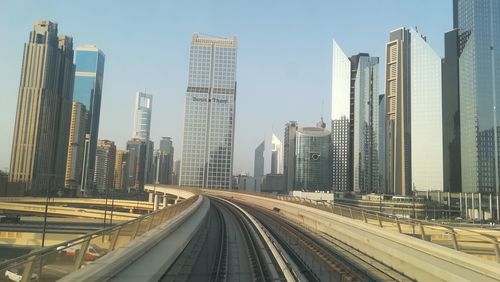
[294,120,332,191]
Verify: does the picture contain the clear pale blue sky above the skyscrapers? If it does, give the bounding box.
[0,0,452,174]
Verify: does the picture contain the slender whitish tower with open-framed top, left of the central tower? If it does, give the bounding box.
[132,92,155,183]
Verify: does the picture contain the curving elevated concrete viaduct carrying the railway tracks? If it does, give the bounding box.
[0,186,500,281]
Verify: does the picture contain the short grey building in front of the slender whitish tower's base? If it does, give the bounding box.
[127,138,147,191]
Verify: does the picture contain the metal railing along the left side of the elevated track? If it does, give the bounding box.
[0,195,198,281]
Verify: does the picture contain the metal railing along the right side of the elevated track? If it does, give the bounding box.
[270,194,500,263]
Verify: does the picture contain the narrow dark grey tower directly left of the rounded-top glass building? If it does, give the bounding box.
[283,121,299,191]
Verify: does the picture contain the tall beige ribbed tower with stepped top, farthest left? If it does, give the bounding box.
[9,20,74,194]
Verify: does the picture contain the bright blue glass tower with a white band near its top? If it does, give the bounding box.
[73,45,105,195]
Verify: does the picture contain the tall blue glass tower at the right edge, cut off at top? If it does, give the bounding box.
[453,0,500,193]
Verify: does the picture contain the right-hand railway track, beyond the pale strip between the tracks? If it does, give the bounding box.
[239,200,411,281]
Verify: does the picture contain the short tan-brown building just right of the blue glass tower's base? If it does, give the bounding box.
[94,140,116,194]
